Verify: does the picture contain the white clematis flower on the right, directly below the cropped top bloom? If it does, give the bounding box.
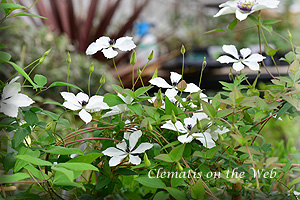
[217,45,266,71]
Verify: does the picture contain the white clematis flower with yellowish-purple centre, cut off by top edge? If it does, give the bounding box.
[214,0,279,21]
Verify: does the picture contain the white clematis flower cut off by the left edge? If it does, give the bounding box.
[0,77,34,117]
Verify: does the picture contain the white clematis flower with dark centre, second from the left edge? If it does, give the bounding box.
[60,92,109,123]
